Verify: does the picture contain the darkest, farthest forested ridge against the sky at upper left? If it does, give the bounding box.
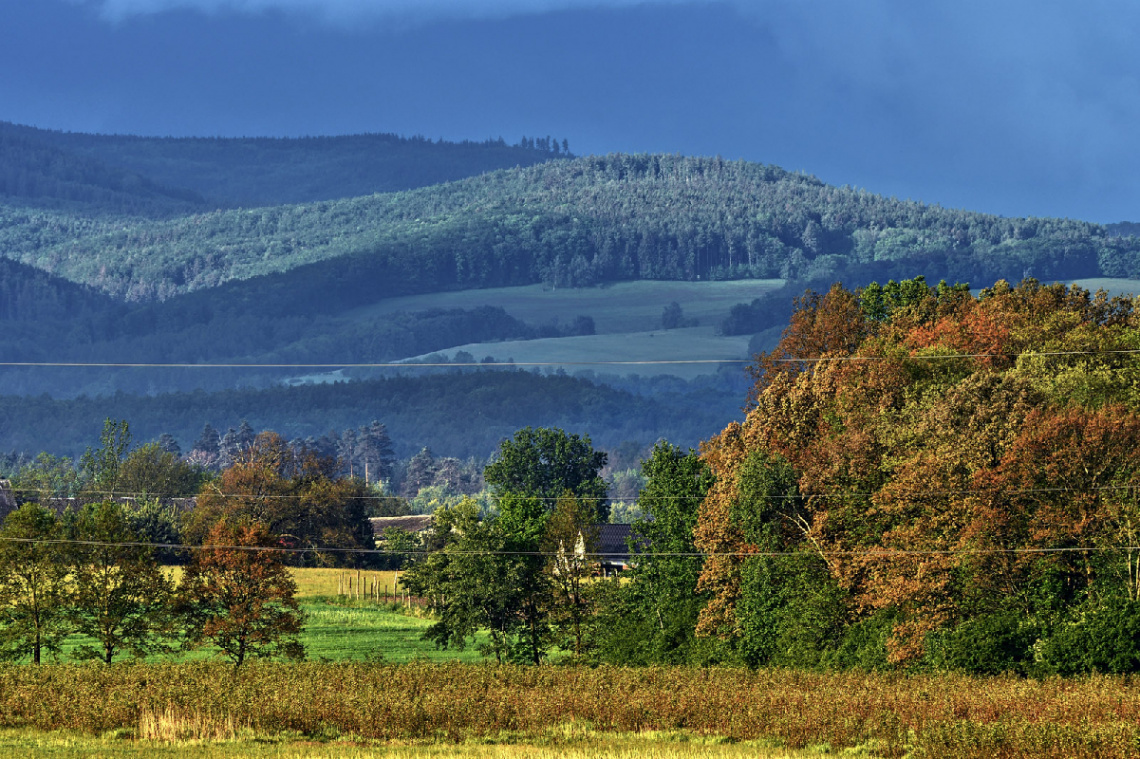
[0,122,569,209]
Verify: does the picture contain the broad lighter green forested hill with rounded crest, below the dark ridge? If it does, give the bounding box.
[0,155,1140,301]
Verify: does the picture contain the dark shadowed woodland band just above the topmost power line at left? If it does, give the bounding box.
[0,296,594,364]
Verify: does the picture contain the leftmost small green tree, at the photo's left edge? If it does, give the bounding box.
[0,504,68,664]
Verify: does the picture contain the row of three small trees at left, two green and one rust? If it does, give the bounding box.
[0,500,303,667]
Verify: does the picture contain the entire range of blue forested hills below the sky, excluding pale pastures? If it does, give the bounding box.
[0,124,1140,455]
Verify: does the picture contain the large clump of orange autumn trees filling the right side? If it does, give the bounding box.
[694,280,1140,671]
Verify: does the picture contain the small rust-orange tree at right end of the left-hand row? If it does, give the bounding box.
[177,522,304,669]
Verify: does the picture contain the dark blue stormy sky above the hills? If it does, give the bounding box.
[0,0,1140,222]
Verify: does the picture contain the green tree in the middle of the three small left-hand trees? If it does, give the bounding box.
[67,501,173,664]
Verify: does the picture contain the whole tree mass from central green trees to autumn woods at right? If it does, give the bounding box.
[406,280,1140,676]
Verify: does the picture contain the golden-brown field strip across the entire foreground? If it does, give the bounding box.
[0,662,1140,759]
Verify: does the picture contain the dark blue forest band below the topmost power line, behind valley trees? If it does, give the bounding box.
[0,369,743,458]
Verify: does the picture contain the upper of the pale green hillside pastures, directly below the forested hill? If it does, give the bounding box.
[344,279,784,334]
